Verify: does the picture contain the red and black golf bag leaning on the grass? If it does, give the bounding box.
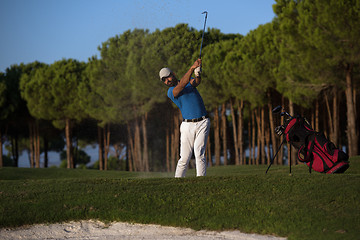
[284,116,349,174]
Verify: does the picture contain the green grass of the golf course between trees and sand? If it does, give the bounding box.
[0,157,360,239]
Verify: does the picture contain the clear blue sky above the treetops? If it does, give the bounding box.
[0,0,275,72]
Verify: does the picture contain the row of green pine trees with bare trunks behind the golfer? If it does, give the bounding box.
[0,0,360,171]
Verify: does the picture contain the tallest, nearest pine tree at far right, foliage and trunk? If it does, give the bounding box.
[274,0,360,156]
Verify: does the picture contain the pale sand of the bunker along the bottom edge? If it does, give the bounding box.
[0,220,286,240]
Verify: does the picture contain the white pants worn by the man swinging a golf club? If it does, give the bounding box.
[175,118,210,178]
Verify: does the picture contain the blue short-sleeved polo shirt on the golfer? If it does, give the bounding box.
[167,83,207,119]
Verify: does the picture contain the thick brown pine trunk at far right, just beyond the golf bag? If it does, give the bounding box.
[345,64,358,157]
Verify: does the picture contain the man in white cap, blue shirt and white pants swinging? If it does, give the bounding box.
[159,59,210,178]
